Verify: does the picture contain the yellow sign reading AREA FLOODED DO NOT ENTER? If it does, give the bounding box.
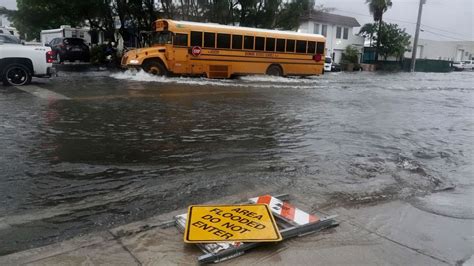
[184,204,281,243]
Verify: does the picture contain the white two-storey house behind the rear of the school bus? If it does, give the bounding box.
[298,12,365,63]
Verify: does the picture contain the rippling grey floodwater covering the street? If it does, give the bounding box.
[0,71,474,255]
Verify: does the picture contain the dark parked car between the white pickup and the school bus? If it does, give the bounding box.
[48,38,90,63]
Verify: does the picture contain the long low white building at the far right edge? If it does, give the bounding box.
[405,39,474,61]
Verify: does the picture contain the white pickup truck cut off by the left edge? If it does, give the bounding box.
[0,35,55,86]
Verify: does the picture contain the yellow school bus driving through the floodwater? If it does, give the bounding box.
[121,19,326,78]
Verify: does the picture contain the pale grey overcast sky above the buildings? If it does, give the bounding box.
[0,0,474,41]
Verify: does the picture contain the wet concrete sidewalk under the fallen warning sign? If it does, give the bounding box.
[0,194,474,265]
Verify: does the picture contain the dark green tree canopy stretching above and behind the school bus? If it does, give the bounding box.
[7,0,323,40]
